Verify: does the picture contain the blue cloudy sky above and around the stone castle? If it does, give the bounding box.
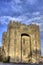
[0,0,43,55]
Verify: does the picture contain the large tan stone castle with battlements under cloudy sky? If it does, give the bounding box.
[2,21,41,63]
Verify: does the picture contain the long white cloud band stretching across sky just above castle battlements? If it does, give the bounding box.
[0,15,43,24]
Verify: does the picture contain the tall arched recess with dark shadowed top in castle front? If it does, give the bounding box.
[21,33,31,63]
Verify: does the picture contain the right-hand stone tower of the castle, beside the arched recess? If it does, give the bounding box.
[29,24,41,63]
